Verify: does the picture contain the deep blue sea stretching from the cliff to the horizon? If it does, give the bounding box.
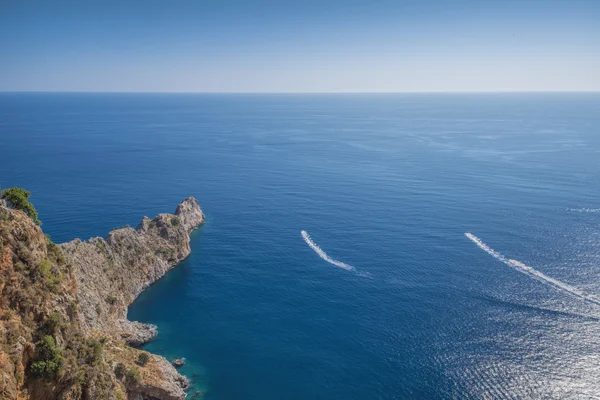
[0,93,600,400]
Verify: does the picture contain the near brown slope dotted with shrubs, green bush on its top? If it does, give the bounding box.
[0,188,117,399]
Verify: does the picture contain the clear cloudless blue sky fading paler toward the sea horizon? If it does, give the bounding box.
[0,0,600,92]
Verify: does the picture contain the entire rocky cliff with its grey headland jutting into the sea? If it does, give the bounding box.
[0,198,204,400]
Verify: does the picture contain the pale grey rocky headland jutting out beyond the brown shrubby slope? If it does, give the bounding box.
[60,198,204,345]
